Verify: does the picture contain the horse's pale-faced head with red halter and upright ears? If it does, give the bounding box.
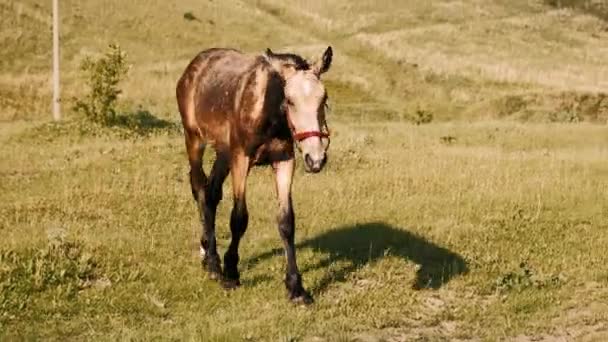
[266,47,332,173]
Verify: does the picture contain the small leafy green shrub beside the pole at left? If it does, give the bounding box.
[74,44,129,124]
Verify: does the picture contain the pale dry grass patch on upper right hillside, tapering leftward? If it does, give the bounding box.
[357,10,608,92]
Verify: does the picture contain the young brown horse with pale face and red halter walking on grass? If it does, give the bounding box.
[176,47,332,304]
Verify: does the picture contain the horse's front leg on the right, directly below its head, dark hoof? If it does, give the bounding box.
[273,158,313,304]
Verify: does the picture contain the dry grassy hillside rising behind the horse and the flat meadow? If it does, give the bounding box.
[0,0,608,122]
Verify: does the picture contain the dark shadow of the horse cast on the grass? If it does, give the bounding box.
[249,222,469,293]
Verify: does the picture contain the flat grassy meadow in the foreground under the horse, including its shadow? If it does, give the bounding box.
[0,122,608,340]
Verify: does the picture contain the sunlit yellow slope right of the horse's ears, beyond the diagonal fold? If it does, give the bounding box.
[254,0,608,122]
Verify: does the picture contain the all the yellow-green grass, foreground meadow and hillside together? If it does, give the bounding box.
[0,0,608,341]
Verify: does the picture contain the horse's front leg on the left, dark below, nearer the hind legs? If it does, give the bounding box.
[223,154,249,288]
